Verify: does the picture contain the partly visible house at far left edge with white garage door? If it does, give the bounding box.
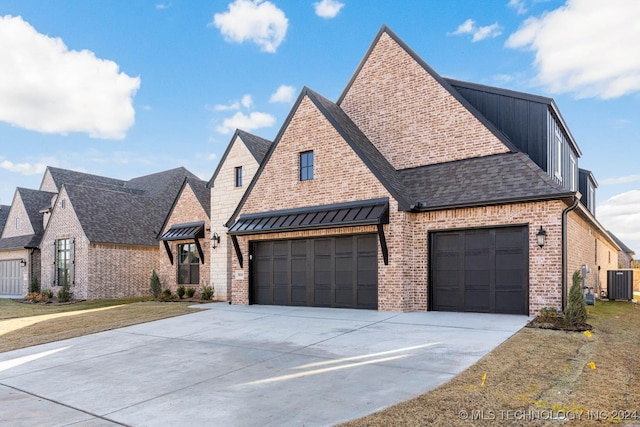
[0,188,55,298]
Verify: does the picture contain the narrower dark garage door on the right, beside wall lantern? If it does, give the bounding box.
[430,227,529,314]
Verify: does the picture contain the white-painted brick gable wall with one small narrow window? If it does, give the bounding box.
[209,136,260,301]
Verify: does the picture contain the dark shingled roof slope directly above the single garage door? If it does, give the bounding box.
[400,153,574,211]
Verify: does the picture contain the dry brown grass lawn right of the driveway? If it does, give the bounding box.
[344,301,640,427]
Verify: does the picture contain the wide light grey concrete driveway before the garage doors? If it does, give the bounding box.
[0,303,528,427]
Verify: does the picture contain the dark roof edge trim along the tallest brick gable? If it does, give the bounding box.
[336,25,519,157]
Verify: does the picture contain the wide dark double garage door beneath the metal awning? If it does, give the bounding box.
[249,234,378,309]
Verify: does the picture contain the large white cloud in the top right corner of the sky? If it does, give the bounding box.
[505,0,640,99]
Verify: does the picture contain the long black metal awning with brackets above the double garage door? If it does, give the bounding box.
[229,198,389,267]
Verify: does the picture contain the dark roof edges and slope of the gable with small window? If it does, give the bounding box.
[225,86,410,226]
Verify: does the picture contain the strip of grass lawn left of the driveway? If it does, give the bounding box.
[0,298,195,352]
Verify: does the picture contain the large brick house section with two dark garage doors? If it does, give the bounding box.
[222,27,618,315]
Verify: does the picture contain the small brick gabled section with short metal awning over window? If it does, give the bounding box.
[158,178,211,293]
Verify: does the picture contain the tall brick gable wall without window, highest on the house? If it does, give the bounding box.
[340,32,509,169]
